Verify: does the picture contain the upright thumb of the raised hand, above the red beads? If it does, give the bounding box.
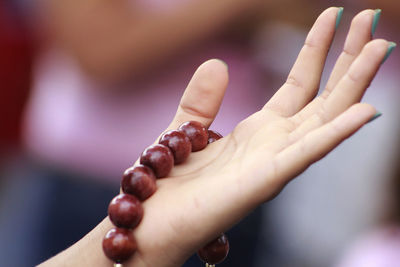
[168,59,229,129]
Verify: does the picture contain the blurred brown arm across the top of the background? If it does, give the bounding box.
[41,0,251,80]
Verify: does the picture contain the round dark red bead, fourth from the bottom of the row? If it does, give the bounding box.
[140,144,174,178]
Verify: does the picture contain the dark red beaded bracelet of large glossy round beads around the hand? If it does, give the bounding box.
[103,121,229,267]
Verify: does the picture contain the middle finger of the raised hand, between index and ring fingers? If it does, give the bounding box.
[293,9,380,125]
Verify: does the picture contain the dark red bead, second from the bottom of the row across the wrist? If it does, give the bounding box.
[108,194,143,228]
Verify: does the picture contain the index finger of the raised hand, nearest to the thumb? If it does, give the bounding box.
[264,7,340,116]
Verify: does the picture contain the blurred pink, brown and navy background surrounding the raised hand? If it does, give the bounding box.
[0,0,400,267]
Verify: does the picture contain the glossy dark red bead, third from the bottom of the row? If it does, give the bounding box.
[121,165,157,201]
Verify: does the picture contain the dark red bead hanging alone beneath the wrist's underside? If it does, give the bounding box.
[197,234,229,264]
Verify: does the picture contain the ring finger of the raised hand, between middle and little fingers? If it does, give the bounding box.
[289,40,388,143]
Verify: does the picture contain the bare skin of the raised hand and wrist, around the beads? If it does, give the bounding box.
[41,8,388,267]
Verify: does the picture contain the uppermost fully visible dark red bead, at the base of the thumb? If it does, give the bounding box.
[179,121,208,152]
